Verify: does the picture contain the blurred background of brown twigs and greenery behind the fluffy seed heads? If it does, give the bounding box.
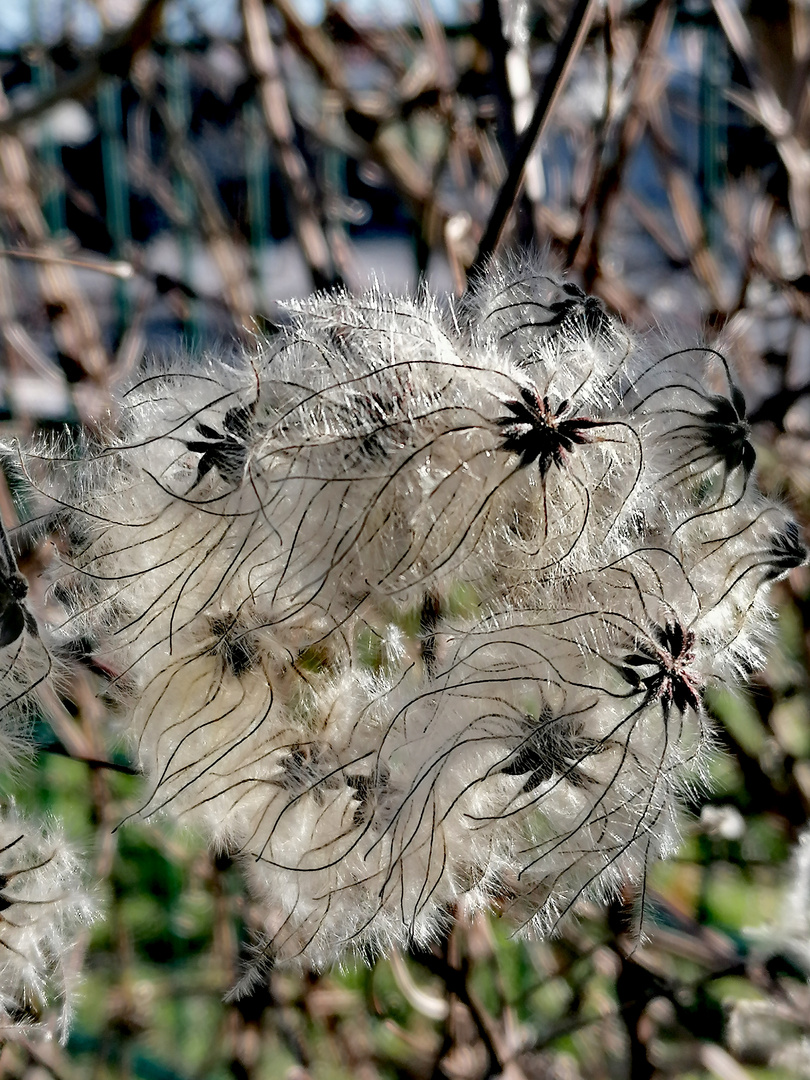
[0,0,810,1080]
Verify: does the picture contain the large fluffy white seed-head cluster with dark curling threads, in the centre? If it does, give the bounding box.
[2,254,806,989]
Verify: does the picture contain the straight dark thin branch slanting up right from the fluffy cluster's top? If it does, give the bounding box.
[470,0,594,275]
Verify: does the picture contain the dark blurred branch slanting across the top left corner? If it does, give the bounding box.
[0,0,165,135]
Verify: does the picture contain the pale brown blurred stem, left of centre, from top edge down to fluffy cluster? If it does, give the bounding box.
[242,0,340,288]
